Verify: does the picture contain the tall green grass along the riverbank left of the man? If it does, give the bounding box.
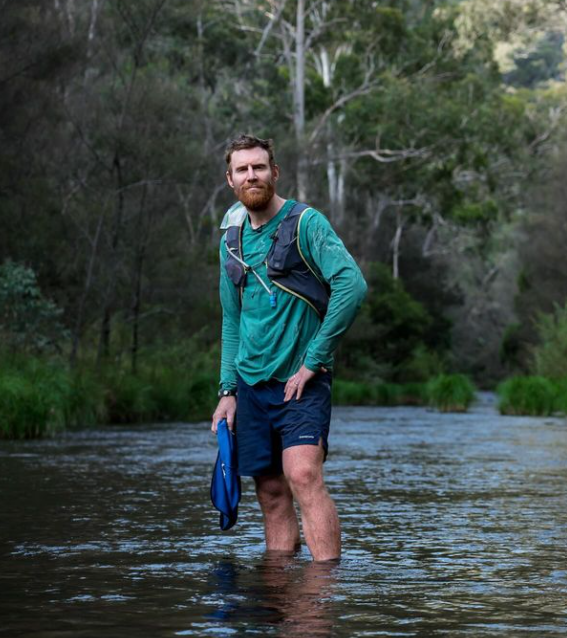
[0,350,217,439]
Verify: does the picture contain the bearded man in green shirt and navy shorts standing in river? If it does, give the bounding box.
[212,135,366,561]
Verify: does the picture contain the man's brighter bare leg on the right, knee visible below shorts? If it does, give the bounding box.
[283,444,341,561]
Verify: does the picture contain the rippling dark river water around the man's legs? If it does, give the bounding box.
[0,395,567,638]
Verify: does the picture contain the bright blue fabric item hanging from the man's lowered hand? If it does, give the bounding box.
[211,419,241,531]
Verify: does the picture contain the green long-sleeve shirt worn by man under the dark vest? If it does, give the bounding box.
[220,200,366,388]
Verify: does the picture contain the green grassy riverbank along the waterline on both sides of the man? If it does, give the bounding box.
[0,351,567,439]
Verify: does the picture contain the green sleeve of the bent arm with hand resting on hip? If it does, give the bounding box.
[299,211,367,372]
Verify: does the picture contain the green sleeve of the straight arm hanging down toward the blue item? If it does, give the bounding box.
[219,236,240,390]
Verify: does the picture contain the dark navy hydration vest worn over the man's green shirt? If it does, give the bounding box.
[221,203,330,320]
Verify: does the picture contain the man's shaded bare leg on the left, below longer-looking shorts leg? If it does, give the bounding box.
[254,474,300,552]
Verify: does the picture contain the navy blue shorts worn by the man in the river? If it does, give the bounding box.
[236,372,331,476]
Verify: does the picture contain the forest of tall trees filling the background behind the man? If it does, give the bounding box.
[0,0,567,384]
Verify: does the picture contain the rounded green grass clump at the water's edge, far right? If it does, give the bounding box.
[497,376,557,416]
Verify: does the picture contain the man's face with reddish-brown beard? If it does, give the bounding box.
[226,147,279,211]
